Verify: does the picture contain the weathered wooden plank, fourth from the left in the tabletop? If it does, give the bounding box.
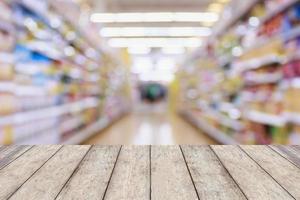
[57,146,120,200]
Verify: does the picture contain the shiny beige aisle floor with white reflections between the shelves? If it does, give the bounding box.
[85,112,216,145]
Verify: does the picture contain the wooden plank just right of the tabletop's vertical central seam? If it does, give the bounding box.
[151,146,198,200]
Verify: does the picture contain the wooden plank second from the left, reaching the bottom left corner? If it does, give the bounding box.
[0,146,61,199]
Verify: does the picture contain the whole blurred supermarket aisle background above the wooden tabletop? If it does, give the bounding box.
[0,0,300,145]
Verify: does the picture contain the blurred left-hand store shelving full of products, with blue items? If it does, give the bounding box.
[0,0,129,144]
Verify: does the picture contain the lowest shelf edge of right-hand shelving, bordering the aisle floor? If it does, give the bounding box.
[179,111,239,145]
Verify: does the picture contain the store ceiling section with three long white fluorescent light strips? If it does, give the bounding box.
[90,0,230,47]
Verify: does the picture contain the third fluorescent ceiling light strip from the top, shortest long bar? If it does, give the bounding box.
[108,38,202,48]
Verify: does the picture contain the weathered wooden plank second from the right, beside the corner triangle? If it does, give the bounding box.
[241,146,300,199]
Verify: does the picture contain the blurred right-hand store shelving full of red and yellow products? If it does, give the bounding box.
[180,0,300,144]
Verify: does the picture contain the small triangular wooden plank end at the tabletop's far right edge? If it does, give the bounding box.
[270,145,300,168]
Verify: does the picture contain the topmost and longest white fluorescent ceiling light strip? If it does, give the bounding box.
[90,12,219,23]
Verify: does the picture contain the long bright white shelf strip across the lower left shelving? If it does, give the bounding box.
[0,97,98,126]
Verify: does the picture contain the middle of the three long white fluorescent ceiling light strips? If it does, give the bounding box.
[100,27,211,37]
